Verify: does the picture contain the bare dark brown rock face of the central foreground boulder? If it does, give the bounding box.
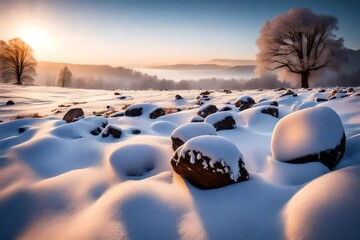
[171,150,249,189]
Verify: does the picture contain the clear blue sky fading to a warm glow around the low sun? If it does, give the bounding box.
[0,0,360,66]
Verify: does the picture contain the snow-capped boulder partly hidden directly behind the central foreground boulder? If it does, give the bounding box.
[171,122,216,151]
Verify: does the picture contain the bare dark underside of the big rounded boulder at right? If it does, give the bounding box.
[286,133,346,170]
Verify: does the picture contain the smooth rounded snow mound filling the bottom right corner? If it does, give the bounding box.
[283,166,360,239]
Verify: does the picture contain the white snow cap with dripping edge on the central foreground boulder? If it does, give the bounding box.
[178,136,243,181]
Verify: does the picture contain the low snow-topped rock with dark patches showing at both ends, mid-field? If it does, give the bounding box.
[125,103,165,119]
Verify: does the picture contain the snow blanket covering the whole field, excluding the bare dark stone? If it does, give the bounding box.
[0,84,360,239]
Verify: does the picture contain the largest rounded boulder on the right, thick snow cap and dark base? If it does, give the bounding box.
[271,107,346,169]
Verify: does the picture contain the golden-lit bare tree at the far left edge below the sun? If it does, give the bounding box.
[0,38,37,85]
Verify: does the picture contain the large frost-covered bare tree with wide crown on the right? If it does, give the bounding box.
[257,8,343,88]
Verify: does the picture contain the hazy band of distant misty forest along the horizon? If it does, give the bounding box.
[34,49,360,90]
